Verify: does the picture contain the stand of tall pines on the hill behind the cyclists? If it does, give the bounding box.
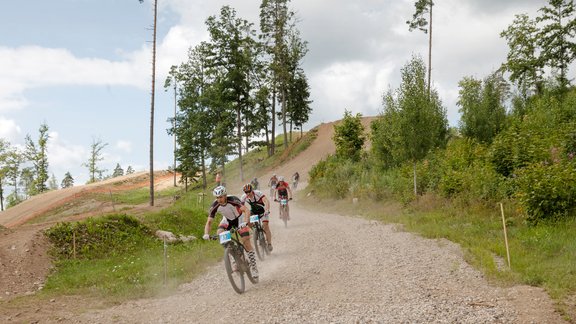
[165,0,311,187]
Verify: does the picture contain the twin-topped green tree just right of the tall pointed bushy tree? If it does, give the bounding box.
[457,72,508,144]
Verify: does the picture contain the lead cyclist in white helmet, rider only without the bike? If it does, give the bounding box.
[202,186,258,278]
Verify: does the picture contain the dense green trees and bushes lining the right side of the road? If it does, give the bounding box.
[310,0,576,223]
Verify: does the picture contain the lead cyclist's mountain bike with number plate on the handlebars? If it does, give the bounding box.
[218,228,258,294]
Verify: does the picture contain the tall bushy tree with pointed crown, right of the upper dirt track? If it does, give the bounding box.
[372,57,448,194]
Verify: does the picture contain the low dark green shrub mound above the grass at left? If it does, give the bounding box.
[45,214,152,259]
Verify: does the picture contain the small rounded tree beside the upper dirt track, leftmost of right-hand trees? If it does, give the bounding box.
[332,110,365,161]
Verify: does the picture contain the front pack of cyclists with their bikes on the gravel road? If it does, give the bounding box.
[203,172,300,293]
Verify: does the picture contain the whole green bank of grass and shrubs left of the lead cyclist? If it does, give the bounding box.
[42,191,222,301]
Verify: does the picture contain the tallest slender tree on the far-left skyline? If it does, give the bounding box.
[24,123,50,195]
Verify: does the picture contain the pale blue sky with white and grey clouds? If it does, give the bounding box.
[0,0,547,189]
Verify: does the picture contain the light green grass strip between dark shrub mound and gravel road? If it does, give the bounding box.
[42,240,222,302]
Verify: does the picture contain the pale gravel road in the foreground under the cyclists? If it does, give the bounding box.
[71,202,562,323]
